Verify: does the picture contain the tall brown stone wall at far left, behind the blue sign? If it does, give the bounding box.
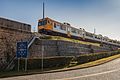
[0,18,32,69]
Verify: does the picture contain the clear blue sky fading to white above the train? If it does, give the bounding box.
[0,0,120,40]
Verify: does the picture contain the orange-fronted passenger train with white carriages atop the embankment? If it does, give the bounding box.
[38,17,120,47]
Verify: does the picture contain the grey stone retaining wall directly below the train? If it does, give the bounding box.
[29,39,111,58]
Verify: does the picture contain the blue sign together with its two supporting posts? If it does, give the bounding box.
[16,41,28,71]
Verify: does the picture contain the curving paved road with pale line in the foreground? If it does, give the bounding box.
[0,58,120,80]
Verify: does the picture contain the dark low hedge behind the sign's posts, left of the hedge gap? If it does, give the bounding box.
[14,57,72,70]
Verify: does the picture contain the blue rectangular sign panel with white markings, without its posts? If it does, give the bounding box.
[16,42,28,58]
